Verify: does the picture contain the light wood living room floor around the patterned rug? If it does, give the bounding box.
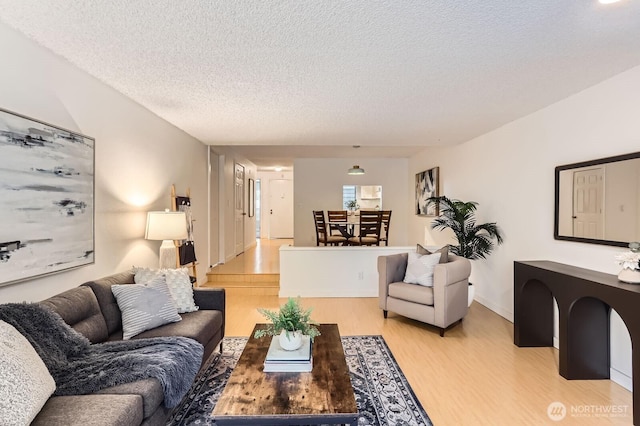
[219,240,633,426]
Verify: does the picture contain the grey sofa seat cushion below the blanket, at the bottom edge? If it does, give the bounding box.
[31,394,143,426]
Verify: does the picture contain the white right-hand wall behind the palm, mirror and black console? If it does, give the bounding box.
[405,67,640,390]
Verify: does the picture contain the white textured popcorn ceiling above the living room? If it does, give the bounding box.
[0,0,640,168]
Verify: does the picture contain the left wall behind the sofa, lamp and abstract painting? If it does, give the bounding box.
[0,23,208,303]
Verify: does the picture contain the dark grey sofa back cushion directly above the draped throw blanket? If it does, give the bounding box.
[40,287,109,343]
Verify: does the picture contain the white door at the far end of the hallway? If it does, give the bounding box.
[269,179,293,238]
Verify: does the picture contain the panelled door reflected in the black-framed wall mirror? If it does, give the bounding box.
[573,167,604,239]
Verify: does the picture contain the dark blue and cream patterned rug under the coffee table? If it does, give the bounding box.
[167,336,432,426]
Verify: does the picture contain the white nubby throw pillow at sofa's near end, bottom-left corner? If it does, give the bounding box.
[0,321,56,425]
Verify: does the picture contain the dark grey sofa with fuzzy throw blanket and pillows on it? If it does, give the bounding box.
[32,272,225,426]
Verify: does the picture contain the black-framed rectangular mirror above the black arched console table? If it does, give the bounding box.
[554,152,640,247]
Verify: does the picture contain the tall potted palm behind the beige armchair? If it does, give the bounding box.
[427,195,503,305]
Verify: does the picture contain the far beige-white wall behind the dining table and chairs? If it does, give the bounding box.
[293,158,410,246]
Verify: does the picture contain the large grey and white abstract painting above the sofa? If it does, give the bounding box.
[0,109,95,285]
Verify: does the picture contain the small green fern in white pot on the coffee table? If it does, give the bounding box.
[254,297,320,350]
